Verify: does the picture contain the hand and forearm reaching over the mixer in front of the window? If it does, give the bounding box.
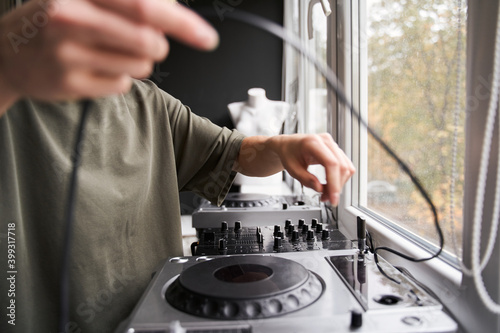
[234,134,355,206]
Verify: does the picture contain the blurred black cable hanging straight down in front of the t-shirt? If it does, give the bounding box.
[58,100,91,332]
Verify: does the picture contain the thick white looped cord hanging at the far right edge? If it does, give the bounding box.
[472,0,500,314]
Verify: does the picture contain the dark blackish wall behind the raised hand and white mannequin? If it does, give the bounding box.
[152,0,283,128]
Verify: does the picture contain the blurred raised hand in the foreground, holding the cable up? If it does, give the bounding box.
[0,0,218,115]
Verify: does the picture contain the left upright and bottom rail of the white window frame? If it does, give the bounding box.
[329,0,461,274]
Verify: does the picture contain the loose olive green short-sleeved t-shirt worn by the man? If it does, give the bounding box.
[0,81,243,333]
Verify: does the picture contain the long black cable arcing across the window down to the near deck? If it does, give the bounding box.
[198,9,444,269]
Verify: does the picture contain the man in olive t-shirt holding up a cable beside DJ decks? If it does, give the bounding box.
[0,0,354,332]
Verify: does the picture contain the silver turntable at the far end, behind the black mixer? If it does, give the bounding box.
[192,193,321,229]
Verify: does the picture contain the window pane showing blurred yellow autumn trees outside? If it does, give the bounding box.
[365,0,466,255]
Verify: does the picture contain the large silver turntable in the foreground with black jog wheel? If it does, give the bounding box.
[117,249,457,333]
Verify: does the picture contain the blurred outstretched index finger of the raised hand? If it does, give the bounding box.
[91,0,219,50]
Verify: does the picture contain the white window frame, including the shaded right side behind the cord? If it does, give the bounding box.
[329,0,500,331]
